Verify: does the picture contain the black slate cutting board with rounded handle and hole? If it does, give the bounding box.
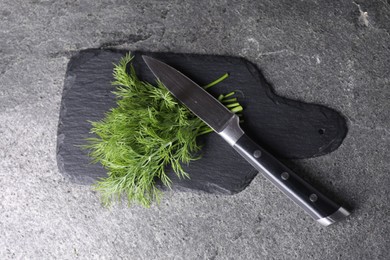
[57,49,347,194]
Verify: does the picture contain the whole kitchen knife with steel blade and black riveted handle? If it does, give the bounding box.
[142,56,350,226]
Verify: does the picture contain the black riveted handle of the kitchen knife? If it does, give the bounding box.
[233,134,350,226]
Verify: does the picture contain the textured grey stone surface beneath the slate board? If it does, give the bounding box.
[0,0,390,259]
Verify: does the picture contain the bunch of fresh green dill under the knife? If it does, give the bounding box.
[85,54,242,206]
